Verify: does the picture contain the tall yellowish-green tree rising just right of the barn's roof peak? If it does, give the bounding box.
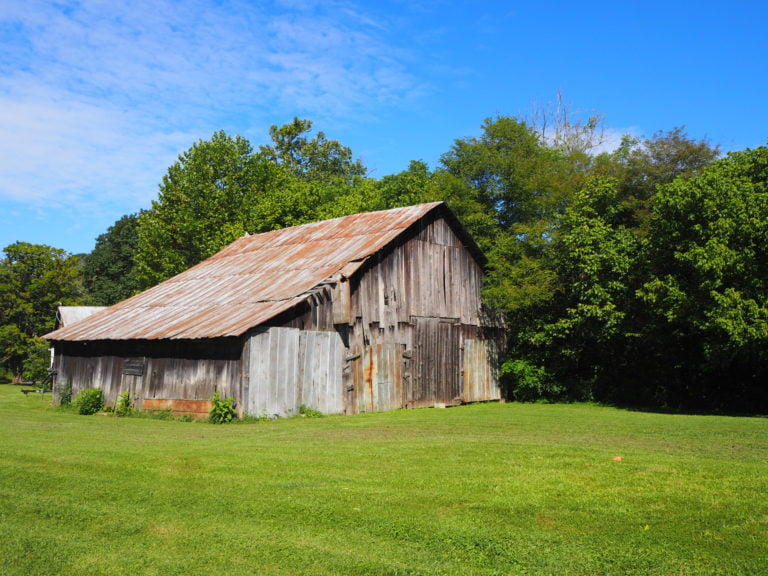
[435,117,583,324]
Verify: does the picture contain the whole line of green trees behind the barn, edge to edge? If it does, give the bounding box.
[0,109,768,412]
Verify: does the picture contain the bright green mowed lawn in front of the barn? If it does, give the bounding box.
[0,385,768,576]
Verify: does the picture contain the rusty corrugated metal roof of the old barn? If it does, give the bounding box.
[45,202,462,341]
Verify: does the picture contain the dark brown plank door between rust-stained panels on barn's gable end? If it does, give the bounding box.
[409,317,463,408]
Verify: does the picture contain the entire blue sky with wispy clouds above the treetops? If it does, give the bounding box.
[0,0,768,253]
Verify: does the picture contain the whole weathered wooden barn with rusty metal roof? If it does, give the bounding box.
[45,202,504,416]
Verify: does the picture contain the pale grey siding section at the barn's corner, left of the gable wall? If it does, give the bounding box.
[246,327,344,416]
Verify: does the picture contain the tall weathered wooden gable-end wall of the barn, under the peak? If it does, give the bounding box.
[342,218,503,413]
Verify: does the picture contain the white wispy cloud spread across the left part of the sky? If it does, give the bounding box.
[0,0,426,209]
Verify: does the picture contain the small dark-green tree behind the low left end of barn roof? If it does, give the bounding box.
[83,214,139,306]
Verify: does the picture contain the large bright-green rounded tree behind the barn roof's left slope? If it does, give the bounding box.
[135,131,287,289]
